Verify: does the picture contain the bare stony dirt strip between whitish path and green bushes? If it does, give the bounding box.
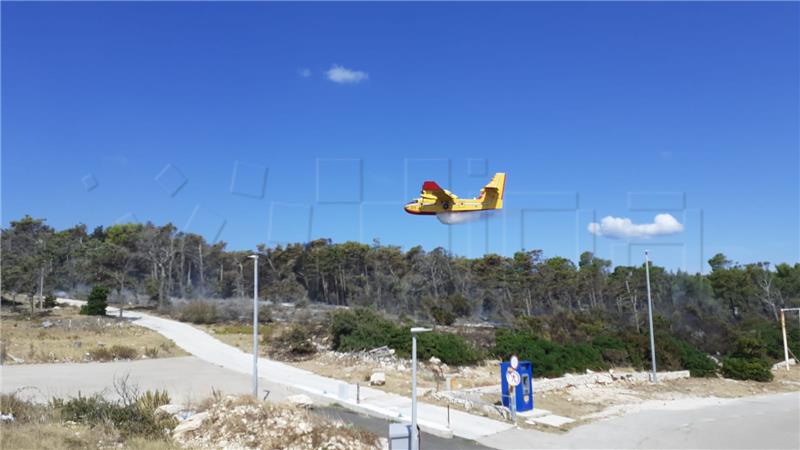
[188,324,800,432]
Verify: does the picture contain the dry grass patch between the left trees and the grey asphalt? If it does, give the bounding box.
[0,307,186,364]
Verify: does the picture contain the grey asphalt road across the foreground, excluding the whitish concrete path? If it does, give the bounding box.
[0,357,800,450]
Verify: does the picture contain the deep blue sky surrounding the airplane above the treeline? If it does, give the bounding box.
[2,2,800,271]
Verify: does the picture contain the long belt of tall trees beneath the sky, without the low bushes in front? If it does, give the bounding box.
[2,216,800,366]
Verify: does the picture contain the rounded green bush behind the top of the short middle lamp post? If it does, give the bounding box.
[329,308,482,365]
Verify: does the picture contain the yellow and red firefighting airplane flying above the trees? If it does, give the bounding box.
[405,173,506,215]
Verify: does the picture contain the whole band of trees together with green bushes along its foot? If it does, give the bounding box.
[2,216,800,378]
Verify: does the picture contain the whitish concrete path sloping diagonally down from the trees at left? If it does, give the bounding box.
[58,298,513,440]
